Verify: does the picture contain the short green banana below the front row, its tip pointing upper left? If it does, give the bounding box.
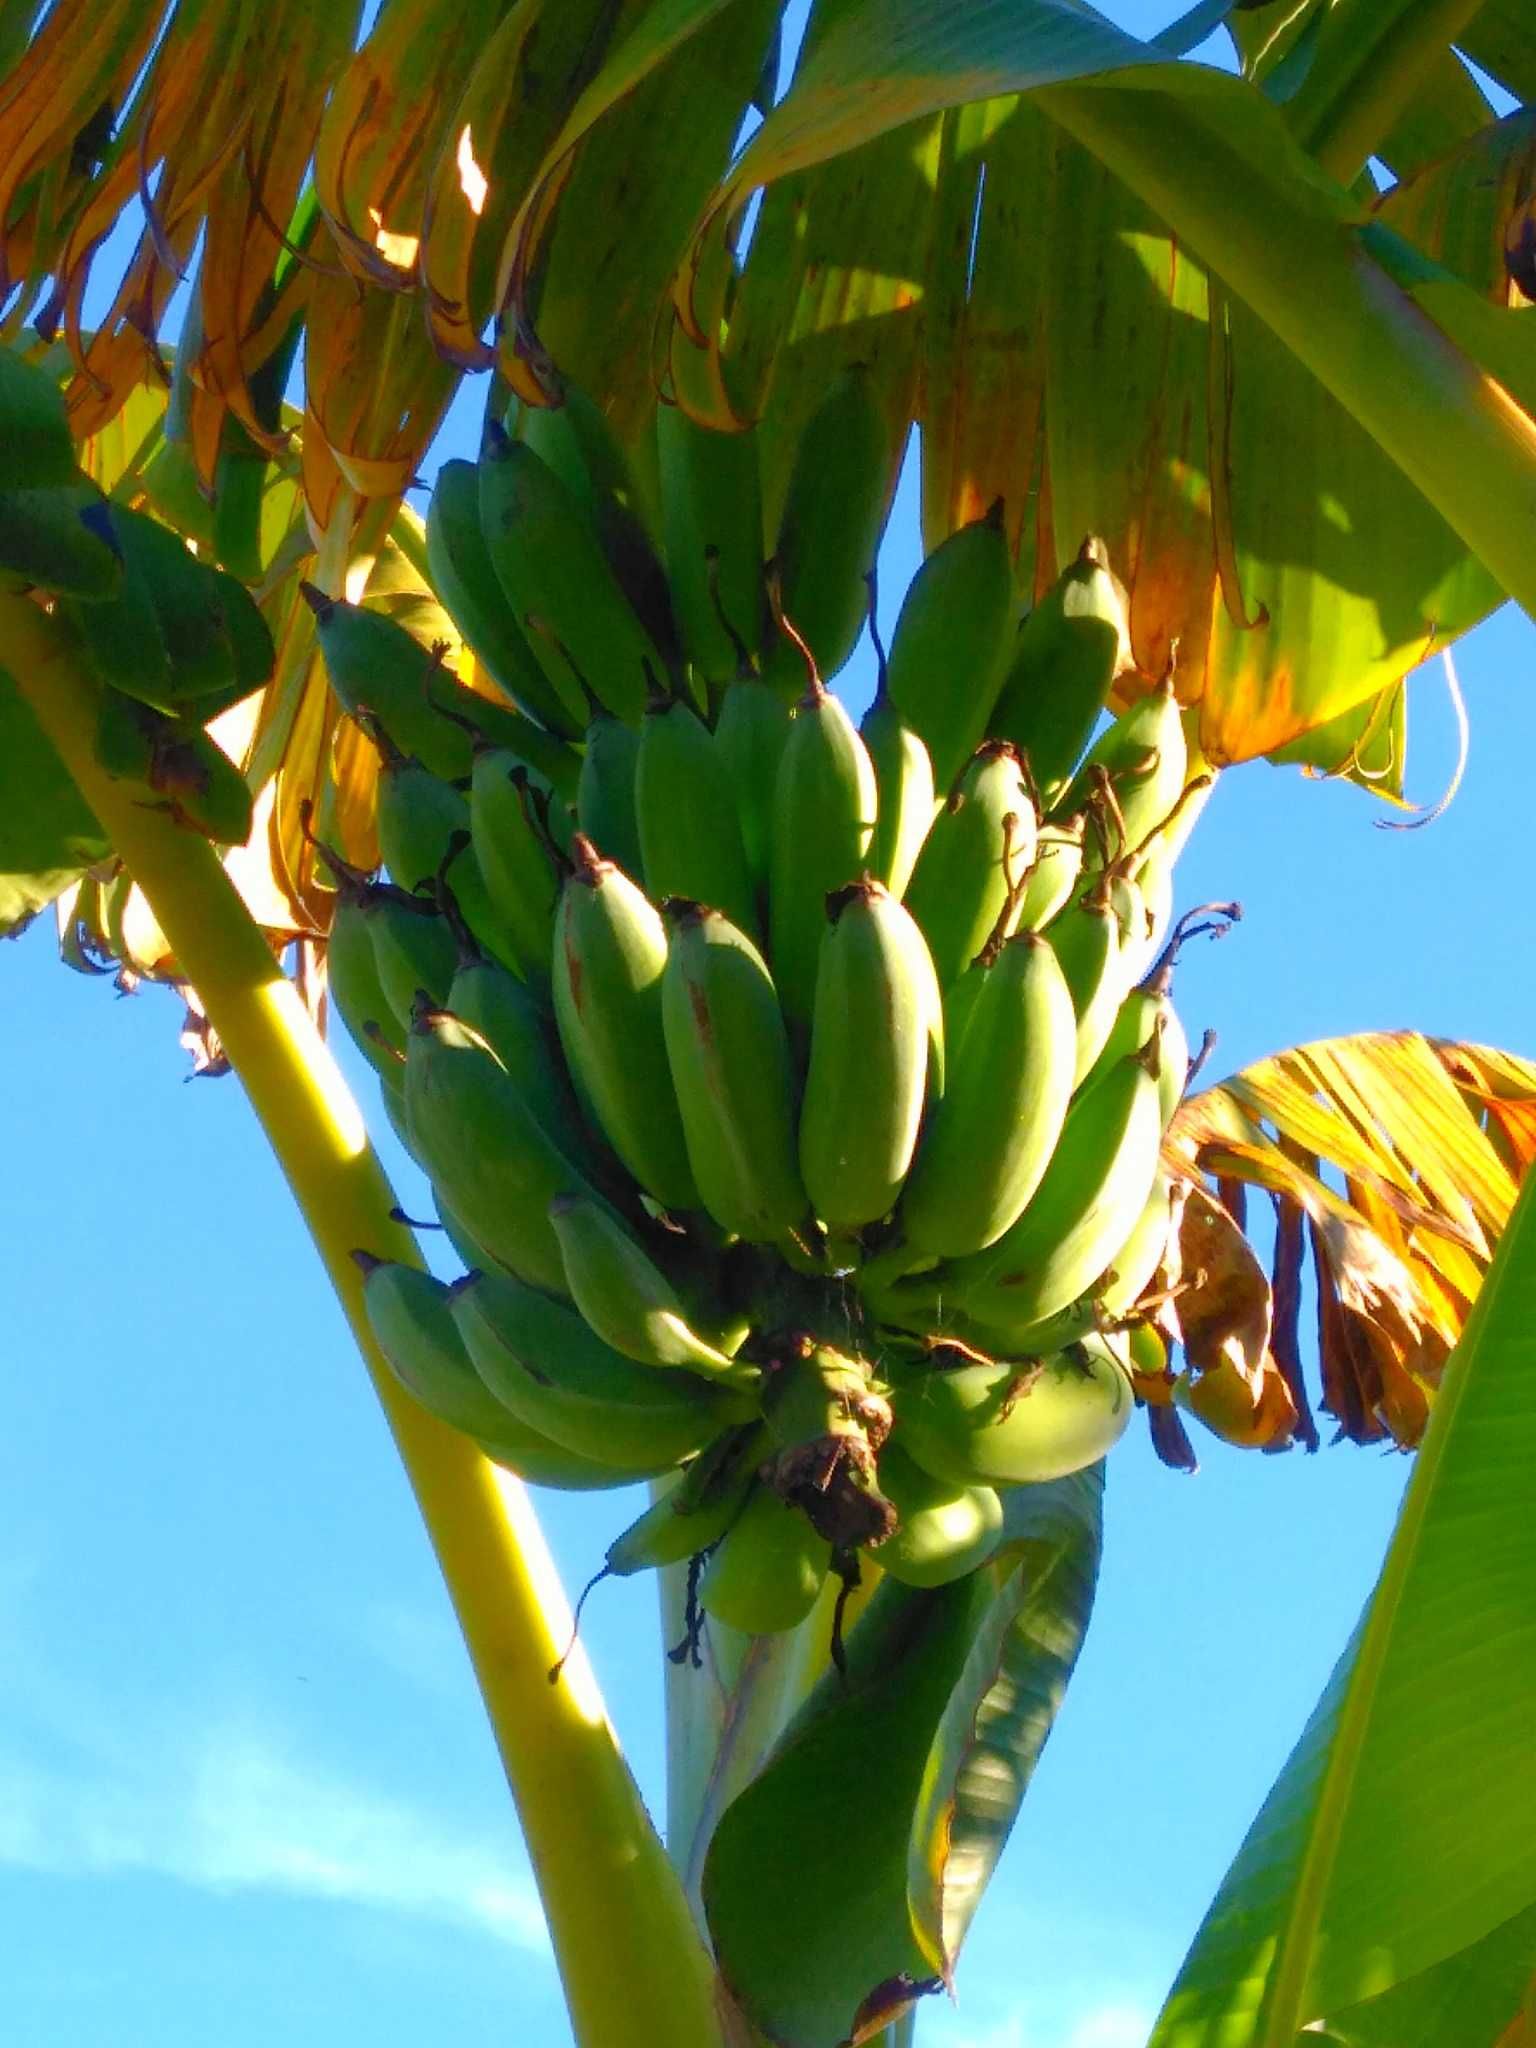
[549,1194,758,1386]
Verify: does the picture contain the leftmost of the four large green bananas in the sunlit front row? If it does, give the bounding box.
[553,834,698,1212]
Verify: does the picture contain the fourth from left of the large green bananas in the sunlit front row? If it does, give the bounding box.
[901,932,1077,1257]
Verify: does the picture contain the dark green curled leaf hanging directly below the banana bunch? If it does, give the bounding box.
[702,1466,1104,2048]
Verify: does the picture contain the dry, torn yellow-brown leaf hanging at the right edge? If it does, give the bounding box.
[1159,1032,1536,1448]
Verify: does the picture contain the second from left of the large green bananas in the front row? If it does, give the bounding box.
[662,897,811,1243]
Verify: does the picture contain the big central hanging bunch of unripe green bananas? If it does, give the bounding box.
[331,373,1236,1632]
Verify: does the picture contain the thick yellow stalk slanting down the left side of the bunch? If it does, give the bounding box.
[0,594,723,2048]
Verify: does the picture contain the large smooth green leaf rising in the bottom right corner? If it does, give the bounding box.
[1151,1180,1536,2048]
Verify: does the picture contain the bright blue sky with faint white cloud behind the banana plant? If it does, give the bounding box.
[0,6,1536,2048]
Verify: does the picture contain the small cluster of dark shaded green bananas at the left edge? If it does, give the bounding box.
[0,348,272,846]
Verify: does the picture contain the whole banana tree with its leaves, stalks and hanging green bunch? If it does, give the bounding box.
[0,0,1536,2048]
